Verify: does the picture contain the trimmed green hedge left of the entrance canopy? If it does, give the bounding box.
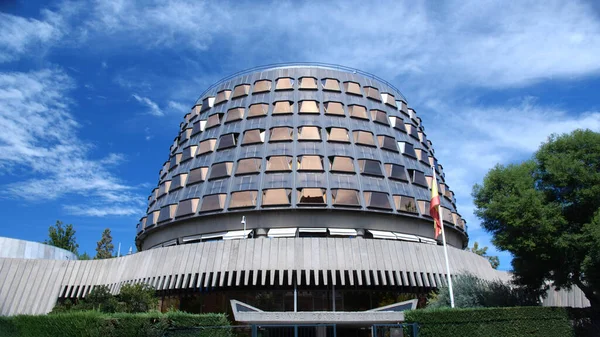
[0,311,229,337]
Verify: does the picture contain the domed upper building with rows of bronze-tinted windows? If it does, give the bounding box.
[137,65,468,250]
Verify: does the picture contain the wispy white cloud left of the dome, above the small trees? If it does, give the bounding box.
[0,70,143,215]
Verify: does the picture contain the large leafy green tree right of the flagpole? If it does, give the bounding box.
[473,130,600,309]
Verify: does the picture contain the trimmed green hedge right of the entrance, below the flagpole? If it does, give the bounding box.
[405,307,574,337]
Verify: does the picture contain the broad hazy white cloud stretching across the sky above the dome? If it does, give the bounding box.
[77,0,600,87]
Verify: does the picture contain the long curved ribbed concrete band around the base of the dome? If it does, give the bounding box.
[0,238,589,315]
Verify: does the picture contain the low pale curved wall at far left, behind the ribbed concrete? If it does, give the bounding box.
[0,237,77,260]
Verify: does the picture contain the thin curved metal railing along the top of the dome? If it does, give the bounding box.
[196,62,406,103]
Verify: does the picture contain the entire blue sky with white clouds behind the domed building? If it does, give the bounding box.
[0,0,600,269]
